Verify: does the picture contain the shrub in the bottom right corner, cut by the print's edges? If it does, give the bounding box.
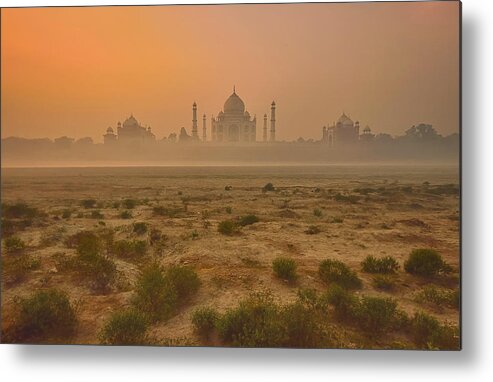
[411,312,460,350]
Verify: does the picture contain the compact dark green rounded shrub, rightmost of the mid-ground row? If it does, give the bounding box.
[404,249,450,277]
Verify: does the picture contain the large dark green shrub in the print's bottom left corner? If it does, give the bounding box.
[9,289,77,343]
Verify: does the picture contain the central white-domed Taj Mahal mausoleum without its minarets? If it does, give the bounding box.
[211,88,257,142]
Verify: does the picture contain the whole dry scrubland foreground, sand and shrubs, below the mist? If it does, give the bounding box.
[1,165,460,349]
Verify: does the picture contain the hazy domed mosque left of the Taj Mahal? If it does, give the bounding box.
[103,115,156,146]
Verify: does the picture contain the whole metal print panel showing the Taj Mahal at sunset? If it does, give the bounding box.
[1,1,461,350]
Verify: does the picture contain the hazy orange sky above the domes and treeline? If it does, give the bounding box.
[1,2,459,142]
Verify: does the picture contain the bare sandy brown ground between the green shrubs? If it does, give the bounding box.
[1,165,459,343]
